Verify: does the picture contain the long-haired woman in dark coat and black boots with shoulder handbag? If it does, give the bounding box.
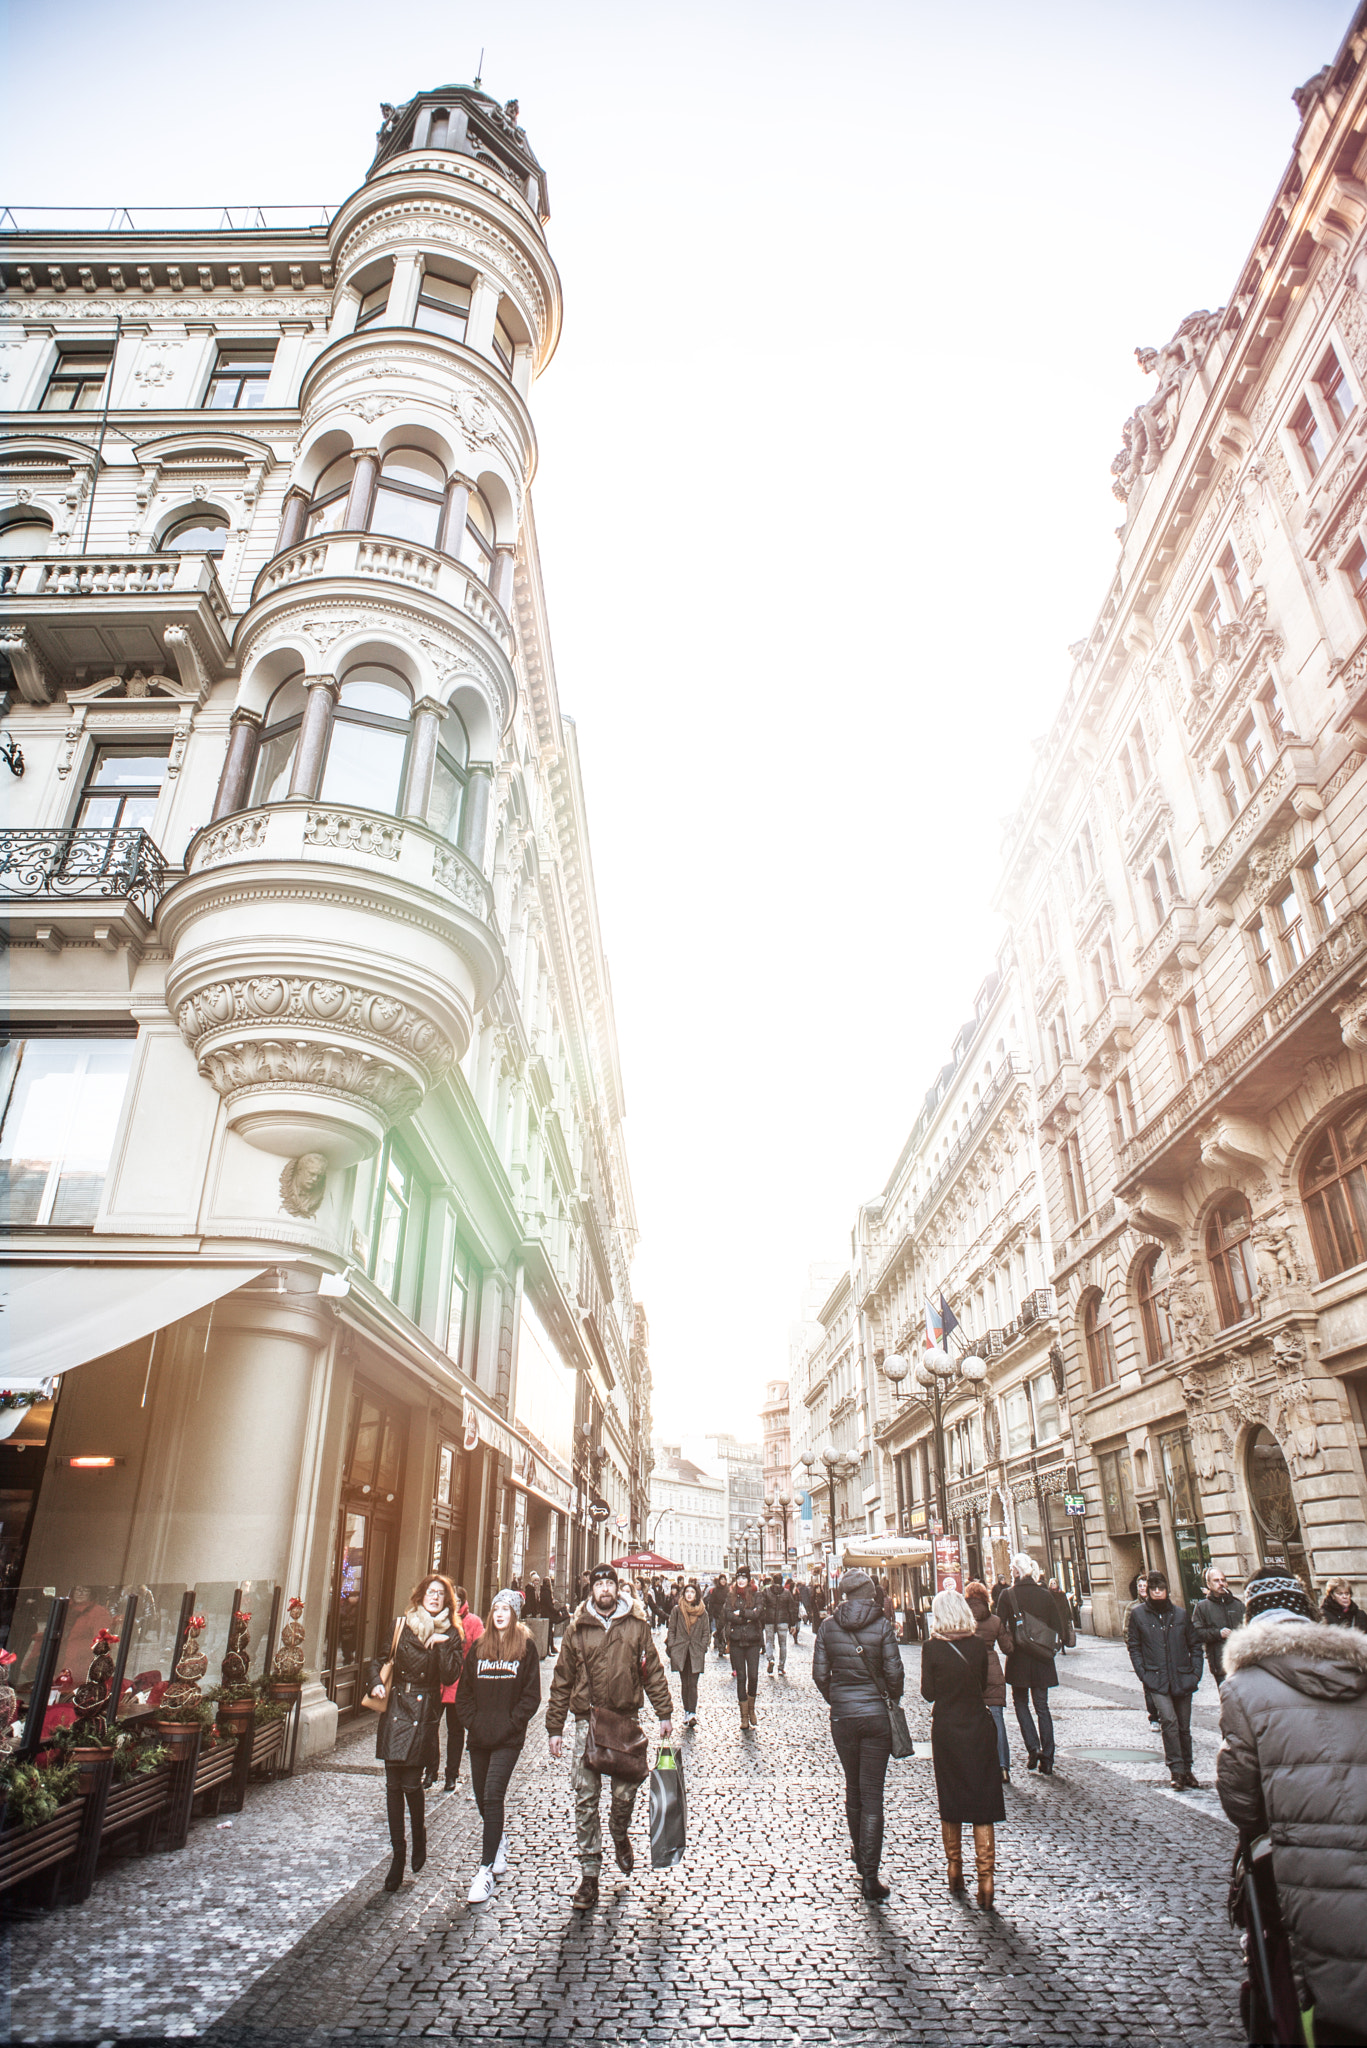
[369,1573,465,1892]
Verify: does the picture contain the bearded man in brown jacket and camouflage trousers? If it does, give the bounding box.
[545,1565,674,1913]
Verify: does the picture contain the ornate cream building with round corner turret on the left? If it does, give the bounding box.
[0,88,650,1739]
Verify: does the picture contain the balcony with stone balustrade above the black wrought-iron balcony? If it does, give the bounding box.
[0,553,232,705]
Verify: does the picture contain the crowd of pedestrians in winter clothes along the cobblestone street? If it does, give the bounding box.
[367,1554,1367,2048]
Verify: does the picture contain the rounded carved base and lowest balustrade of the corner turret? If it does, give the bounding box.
[158,803,502,1167]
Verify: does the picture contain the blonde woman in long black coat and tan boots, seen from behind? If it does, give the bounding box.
[920,1593,1006,1911]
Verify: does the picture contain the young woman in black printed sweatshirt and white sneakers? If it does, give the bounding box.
[457,1581,541,1907]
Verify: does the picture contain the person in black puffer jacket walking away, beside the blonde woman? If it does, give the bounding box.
[812,1569,906,1901]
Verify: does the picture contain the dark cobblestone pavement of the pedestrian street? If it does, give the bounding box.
[0,1630,1242,2048]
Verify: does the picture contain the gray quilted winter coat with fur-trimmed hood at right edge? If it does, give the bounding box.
[1215,1620,1367,2040]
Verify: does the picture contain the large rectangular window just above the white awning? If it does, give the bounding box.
[0,1038,133,1229]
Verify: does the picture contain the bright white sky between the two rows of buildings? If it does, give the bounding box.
[0,0,1351,1436]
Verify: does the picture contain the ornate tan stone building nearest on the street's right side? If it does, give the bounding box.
[1000,28,1367,1628]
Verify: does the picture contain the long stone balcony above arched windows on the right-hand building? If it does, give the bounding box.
[1117,911,1367,1200]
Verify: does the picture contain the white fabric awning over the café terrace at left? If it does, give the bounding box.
[0,1262,266,1389]
